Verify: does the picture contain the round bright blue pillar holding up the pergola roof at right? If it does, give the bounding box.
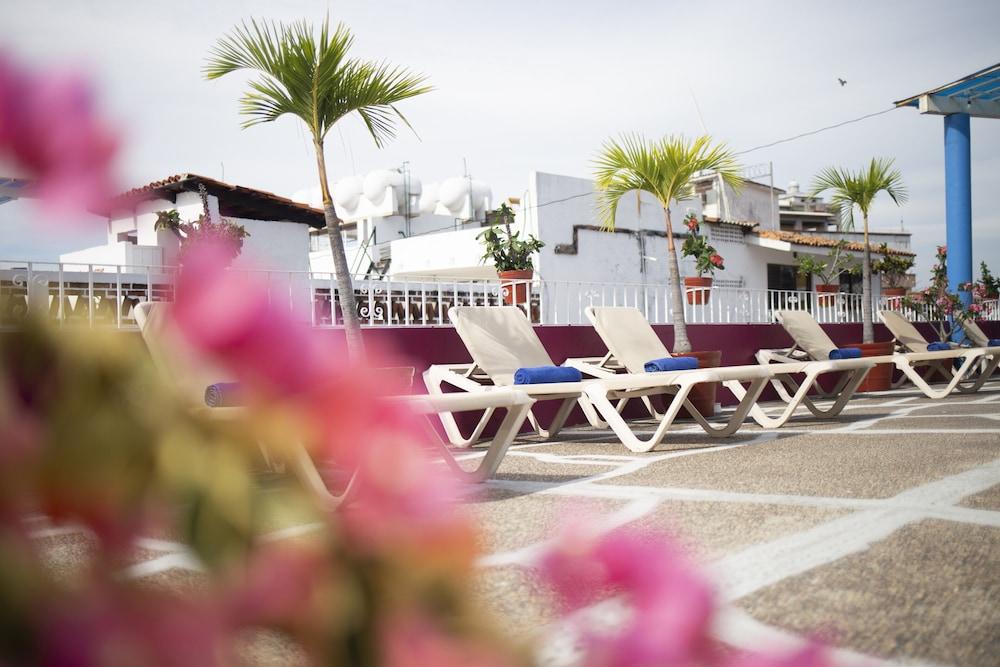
[944,113,972,342]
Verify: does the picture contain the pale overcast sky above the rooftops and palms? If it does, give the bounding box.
[0,0,1000,282]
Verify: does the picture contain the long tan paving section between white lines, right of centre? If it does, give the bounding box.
[602,432,1000,498]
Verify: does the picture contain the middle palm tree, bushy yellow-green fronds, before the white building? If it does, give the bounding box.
[594,134,743,352]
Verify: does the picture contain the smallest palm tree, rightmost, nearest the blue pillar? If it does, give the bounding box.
[811,158,907,343]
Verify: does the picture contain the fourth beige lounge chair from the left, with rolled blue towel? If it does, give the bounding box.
[757,310,982,399]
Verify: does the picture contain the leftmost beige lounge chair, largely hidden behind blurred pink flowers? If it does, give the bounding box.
[135,302,534,506]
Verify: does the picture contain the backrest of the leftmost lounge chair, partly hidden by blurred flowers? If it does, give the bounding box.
[134,301,232,406]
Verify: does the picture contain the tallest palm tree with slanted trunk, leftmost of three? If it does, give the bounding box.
[204,19,431,357]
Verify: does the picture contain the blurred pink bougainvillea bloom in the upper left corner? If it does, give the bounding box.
[0,54,118,217]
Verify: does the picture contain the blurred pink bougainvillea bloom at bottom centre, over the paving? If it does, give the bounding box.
[540,528,714,667]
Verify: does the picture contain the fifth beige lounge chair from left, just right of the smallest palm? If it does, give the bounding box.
[878,310,1000,393]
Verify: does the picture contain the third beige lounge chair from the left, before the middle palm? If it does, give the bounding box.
[580,306,875,428]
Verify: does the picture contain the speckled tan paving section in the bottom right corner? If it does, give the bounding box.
[739,521,1000,667]
